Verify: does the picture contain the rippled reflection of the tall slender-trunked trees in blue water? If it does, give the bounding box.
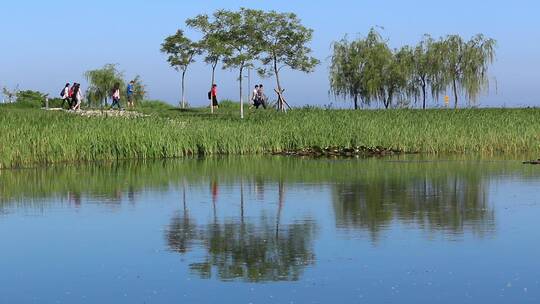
[166,181,317,282]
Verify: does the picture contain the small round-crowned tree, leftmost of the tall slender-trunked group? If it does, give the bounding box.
[161,30,201,108]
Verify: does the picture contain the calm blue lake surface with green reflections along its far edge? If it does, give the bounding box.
[0,156,540,303]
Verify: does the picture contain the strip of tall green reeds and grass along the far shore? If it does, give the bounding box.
[0,103,540,168]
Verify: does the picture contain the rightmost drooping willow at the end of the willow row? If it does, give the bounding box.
[441,34,496,108]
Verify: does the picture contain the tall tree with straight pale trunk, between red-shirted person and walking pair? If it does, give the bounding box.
[214,8,264,118]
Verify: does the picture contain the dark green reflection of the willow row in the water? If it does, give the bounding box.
[333,173,495,242]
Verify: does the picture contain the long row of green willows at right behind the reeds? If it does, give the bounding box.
[330,29,496,109]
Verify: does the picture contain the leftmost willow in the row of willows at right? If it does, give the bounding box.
[330,38,369,110]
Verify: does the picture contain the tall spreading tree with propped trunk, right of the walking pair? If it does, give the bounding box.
[258,11,319,111]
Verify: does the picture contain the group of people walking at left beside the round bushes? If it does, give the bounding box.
[60,81,135,111]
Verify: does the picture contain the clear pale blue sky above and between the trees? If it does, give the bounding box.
[0,0,540,108]
